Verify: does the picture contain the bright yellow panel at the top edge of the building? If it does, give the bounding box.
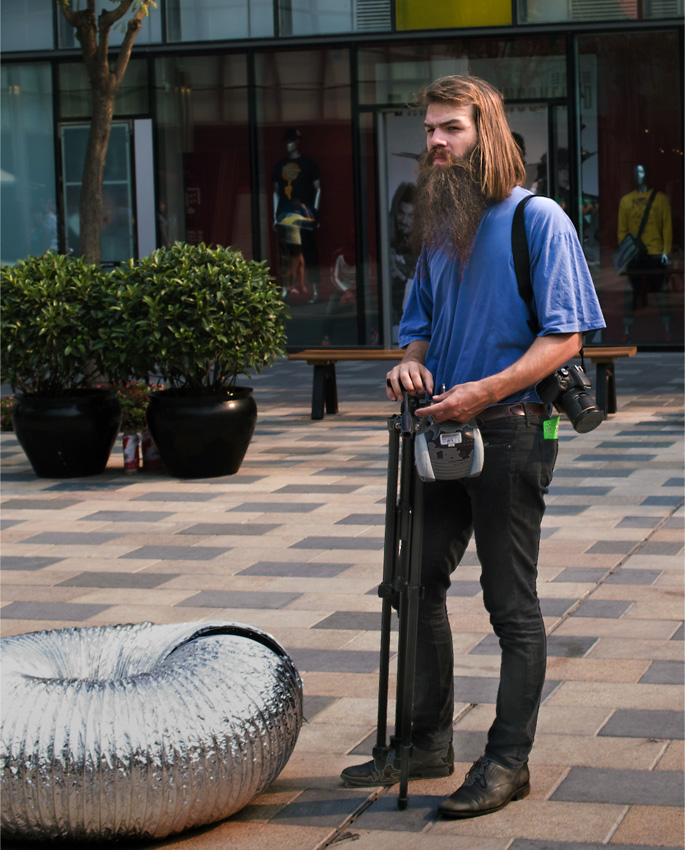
[395,0,511,30]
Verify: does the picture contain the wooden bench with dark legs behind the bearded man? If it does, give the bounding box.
[288,345,637,419]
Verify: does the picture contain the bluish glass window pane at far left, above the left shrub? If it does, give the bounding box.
[0,63,58,263]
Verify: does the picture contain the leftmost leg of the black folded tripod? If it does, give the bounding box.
[373,416,400,763]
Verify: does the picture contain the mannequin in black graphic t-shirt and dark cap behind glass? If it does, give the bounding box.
[272,128,321,304]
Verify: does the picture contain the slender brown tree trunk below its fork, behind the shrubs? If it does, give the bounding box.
[79,88,116,264]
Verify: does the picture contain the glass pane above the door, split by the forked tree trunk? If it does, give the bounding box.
[58,58,150,119]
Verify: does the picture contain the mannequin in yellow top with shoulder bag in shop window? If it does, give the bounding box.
[617,164,673,341]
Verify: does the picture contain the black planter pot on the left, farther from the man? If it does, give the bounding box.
[12,389,121,478]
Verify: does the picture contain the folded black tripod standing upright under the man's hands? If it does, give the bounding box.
[373,391,423,810]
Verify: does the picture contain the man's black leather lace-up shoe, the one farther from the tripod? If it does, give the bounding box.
[438,756,530,818]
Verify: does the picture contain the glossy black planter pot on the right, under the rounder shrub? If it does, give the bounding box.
[147,387,257,478]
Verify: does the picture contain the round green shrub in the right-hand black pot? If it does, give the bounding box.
[111,243,286,394]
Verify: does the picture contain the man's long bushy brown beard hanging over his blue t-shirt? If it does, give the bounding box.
[411,150,485,268]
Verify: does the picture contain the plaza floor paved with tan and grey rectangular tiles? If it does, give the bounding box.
[1,353,683,850]
